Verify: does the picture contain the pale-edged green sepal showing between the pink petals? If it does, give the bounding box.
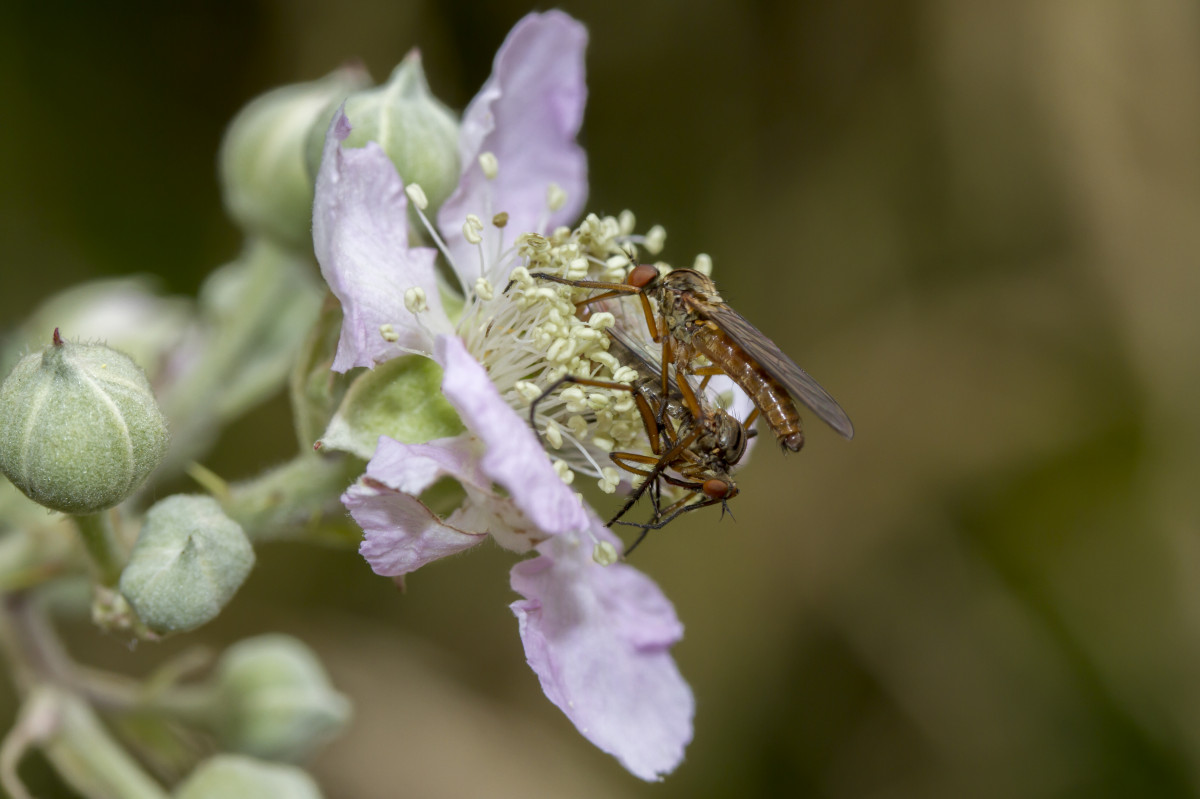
[320,355,463,461]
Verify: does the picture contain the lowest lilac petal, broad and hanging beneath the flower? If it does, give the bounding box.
[510,521,695,780]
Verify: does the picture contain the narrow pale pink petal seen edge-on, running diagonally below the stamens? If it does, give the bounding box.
[433,336,589,534]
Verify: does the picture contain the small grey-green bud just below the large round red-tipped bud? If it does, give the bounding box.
[120,494,254,633]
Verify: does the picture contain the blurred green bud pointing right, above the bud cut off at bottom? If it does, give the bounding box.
[214,635,350,761]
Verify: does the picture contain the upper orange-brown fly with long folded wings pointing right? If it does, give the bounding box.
[532,264,854,452]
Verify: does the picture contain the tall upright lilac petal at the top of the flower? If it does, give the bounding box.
[438,11,588,279]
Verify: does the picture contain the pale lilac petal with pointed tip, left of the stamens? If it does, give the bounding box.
[312,112,451,372]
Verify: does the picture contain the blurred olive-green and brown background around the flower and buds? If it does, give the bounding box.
[0,0,1200,799]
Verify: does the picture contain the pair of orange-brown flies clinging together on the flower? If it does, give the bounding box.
[530,264,854,548]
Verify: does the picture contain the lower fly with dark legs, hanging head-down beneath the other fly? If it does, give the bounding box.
[529,321,758,554]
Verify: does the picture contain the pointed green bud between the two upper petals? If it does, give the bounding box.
[308,50,458,211]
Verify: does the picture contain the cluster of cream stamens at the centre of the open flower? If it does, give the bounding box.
[406,163,681,493]
